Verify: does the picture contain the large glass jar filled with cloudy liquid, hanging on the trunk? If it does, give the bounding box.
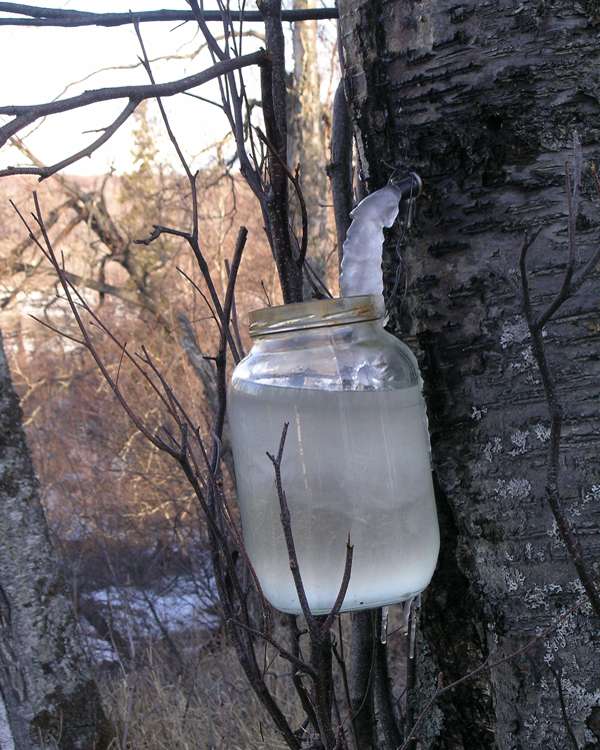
[229,296,439,614]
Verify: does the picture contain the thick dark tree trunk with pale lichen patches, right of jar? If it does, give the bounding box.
[339,0,600,750]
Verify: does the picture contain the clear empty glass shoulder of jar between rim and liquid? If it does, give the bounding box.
[231,325,421,390]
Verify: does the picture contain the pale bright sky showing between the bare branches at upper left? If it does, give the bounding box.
[0,0,300,175]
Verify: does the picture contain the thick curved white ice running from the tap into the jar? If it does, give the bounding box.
[340,184,402,297]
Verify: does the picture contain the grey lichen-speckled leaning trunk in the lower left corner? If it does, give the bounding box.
[0,332,110,750]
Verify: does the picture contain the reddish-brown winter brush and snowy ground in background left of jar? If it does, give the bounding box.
[0,104,336,750]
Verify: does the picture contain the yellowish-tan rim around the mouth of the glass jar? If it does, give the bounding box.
[248,294,385,338]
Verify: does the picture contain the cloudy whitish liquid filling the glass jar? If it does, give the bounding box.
[229,381,439,613]
